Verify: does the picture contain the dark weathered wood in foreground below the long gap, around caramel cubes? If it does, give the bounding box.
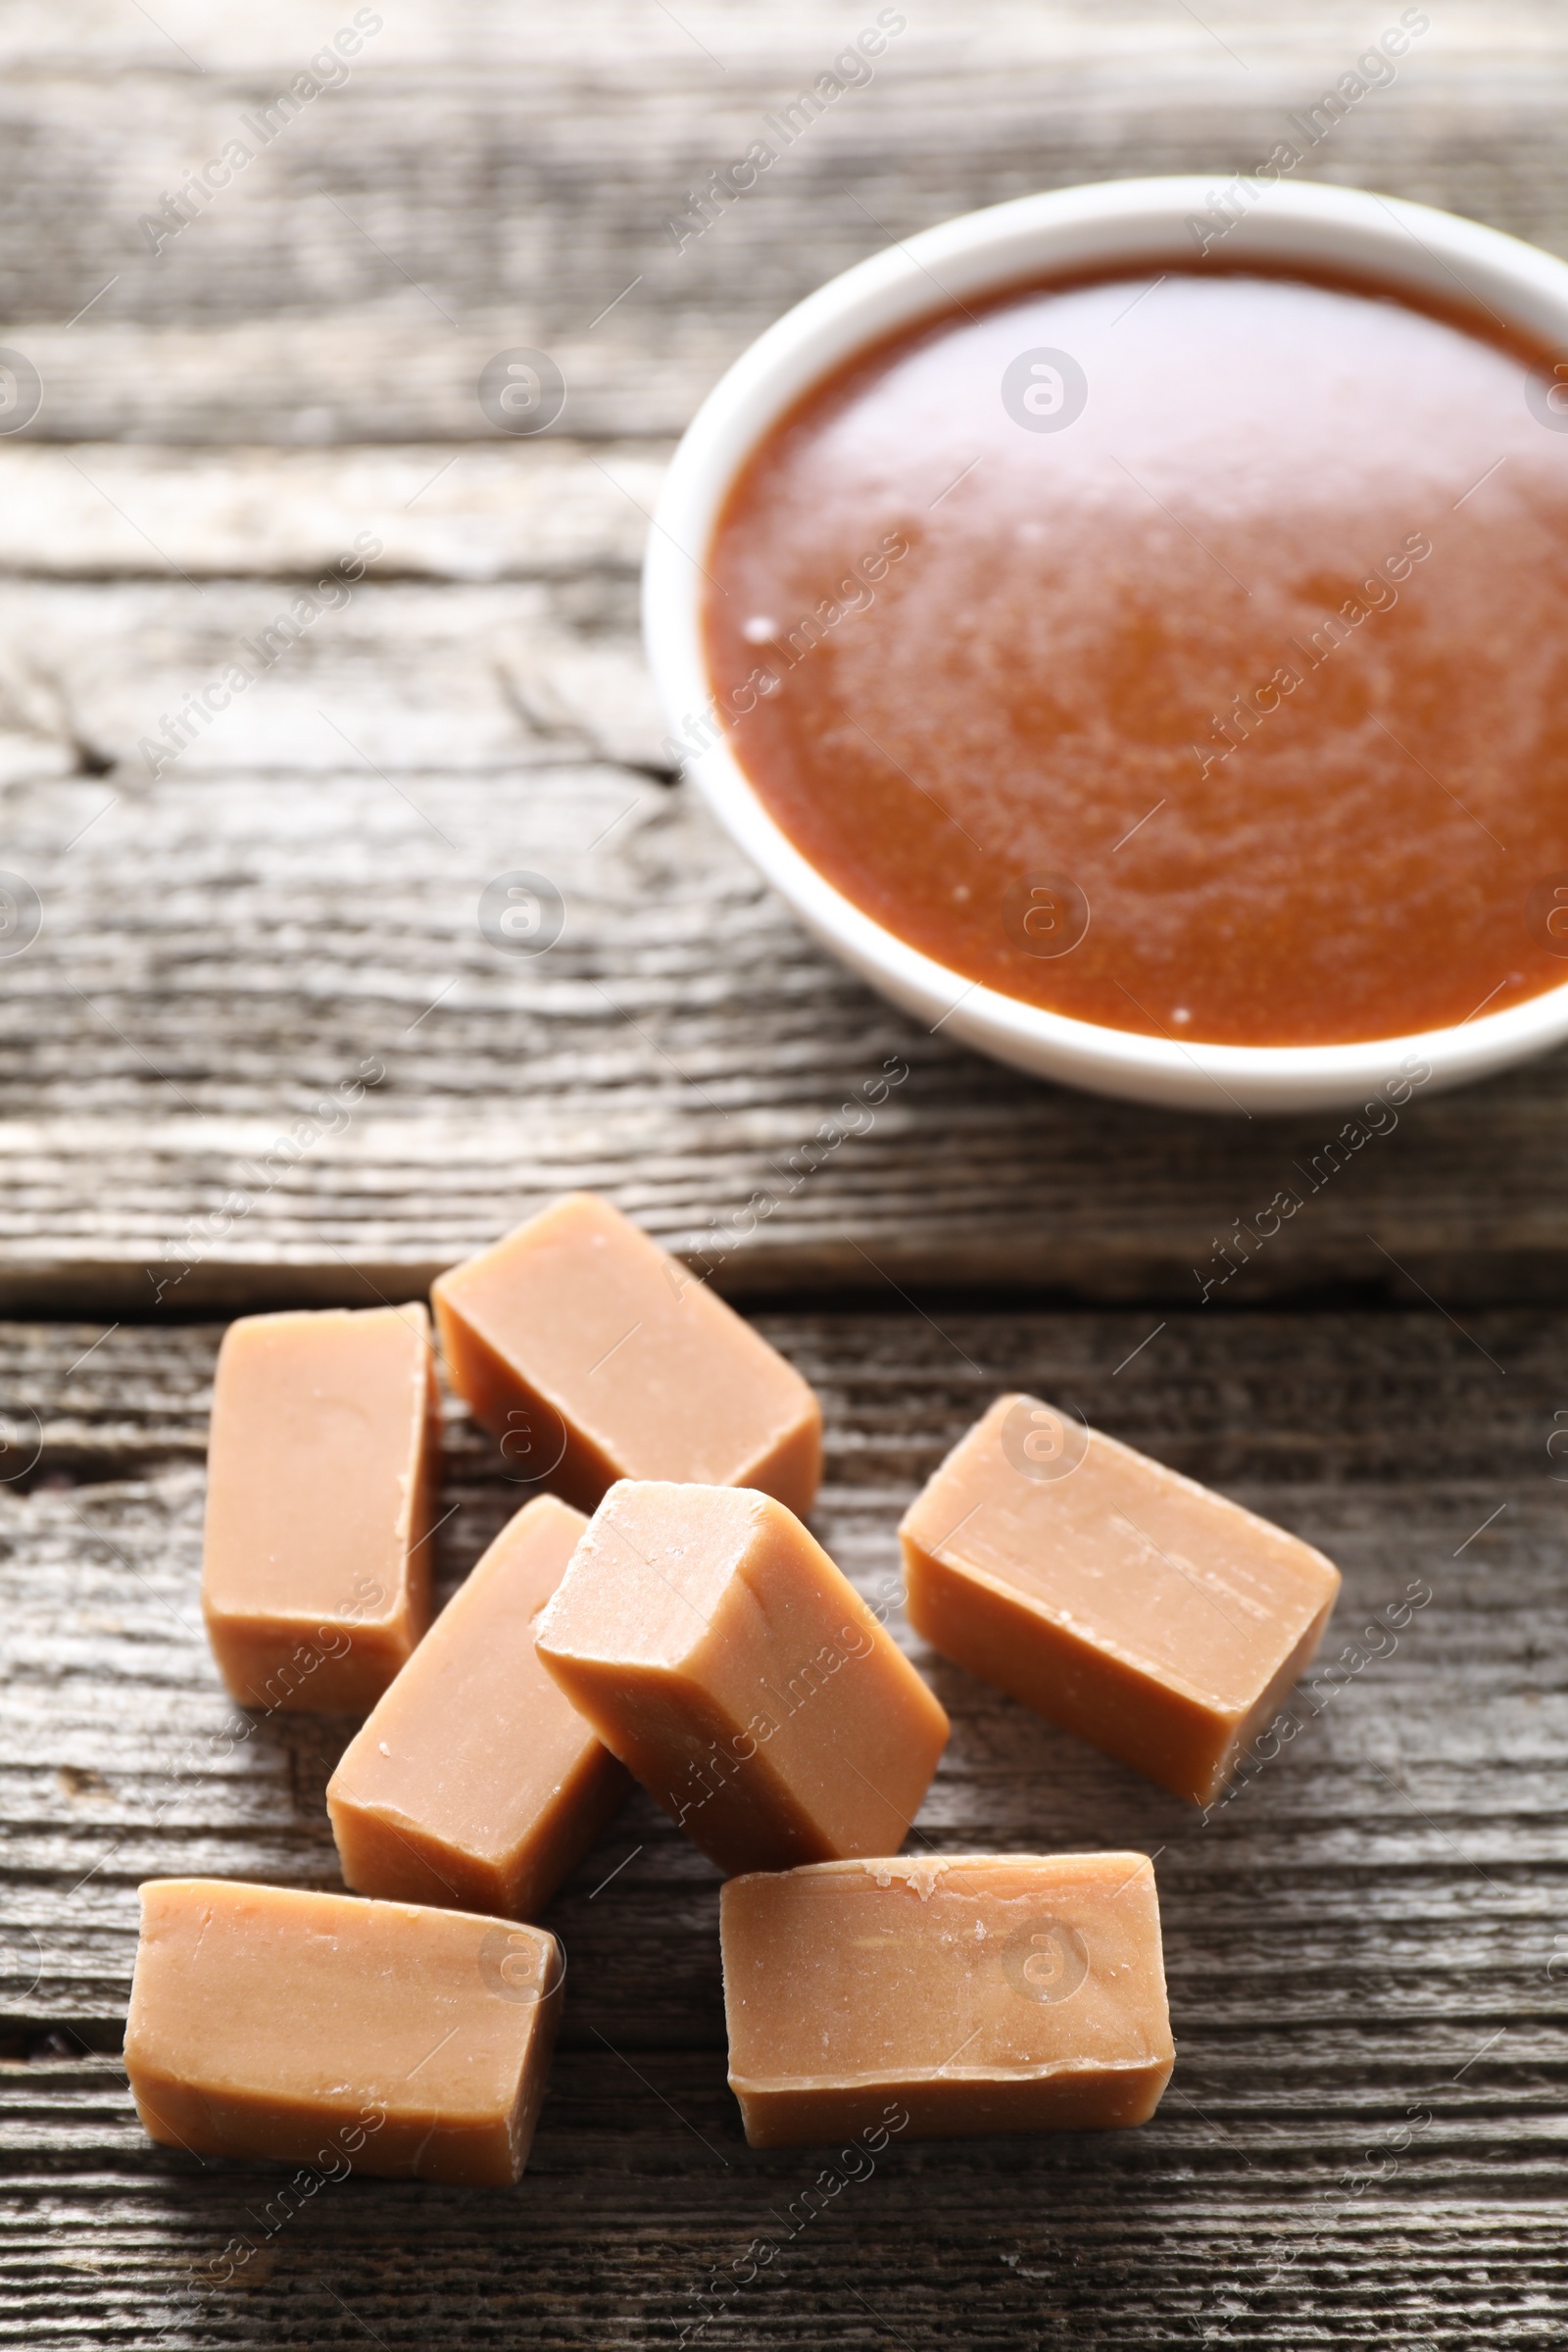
[0,1312,1568,2352]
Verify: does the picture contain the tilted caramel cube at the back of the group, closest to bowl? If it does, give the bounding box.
[430,1193,823,1510]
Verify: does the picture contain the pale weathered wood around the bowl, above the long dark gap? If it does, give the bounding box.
[0,0,1568,1312]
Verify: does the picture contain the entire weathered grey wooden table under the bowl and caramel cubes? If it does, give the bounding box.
[0,0,1568,2352]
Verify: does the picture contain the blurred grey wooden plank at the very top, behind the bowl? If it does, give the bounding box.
[0,0,1568,442]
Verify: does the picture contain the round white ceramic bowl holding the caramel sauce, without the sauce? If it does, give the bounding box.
[642,178,1568,1112]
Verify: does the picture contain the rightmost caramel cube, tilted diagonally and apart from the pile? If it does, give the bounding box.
[901,1397,1340,1804]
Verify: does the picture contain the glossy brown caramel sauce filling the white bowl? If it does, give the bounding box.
[708,270,1568,1045]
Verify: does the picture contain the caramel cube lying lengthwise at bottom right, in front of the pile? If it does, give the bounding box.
[719,1853,1175,2147]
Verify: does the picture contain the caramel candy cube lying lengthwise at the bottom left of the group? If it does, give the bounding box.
[124,1880,564,2185]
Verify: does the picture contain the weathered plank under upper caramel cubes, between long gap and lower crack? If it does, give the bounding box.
[0,1315,1568,2036]
